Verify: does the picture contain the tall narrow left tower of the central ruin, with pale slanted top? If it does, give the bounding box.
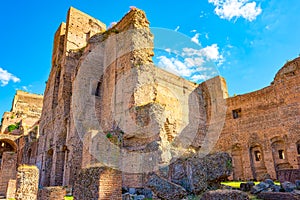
[37,7,105,186]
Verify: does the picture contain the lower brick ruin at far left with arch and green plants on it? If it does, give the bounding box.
[0,90,43,197]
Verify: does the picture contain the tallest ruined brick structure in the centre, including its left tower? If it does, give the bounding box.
[37,8,227,191]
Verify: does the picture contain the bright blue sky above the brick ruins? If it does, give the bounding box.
[0,0,300,113]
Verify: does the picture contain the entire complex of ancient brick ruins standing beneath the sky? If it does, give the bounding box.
[0,7,300,199]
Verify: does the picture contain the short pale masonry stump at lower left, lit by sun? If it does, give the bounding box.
[16,165,39,200]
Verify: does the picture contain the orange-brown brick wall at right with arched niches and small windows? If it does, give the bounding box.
[216,58,300,179]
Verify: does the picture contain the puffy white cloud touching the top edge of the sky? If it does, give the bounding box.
[208,0,262,21]
